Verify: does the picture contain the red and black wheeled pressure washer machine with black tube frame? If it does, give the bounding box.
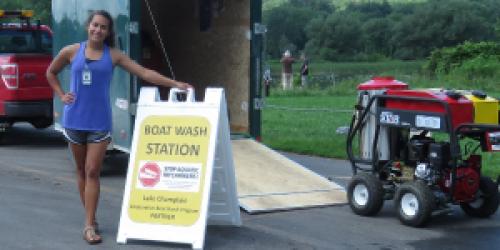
[346,77,500,227]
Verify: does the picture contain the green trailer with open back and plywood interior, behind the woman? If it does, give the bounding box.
[52,0,265,152]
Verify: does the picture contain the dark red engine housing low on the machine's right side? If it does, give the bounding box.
[440,155,481,202]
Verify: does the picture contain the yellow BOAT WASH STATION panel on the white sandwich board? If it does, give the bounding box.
[128,115,211,226]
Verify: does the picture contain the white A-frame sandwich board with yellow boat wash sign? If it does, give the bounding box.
[117,87,241,249]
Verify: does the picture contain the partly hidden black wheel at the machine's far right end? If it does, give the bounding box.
[460,177,499,218]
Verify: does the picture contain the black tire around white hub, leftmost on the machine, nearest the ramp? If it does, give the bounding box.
[347,173,384,216]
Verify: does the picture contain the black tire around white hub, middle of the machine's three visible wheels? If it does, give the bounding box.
[395,181,436,227]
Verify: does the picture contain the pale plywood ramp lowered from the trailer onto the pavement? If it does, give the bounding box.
[231,139,347,213]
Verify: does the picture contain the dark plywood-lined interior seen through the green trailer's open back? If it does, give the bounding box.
[131,0,261,136]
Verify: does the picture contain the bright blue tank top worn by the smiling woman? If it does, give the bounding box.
[63,42,113,131]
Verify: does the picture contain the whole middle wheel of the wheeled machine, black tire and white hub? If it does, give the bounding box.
[396,181,435,227]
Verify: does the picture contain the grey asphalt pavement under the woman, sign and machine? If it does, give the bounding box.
[0,124,500,250]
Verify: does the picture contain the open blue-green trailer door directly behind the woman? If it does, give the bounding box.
[52,0,134,151]
